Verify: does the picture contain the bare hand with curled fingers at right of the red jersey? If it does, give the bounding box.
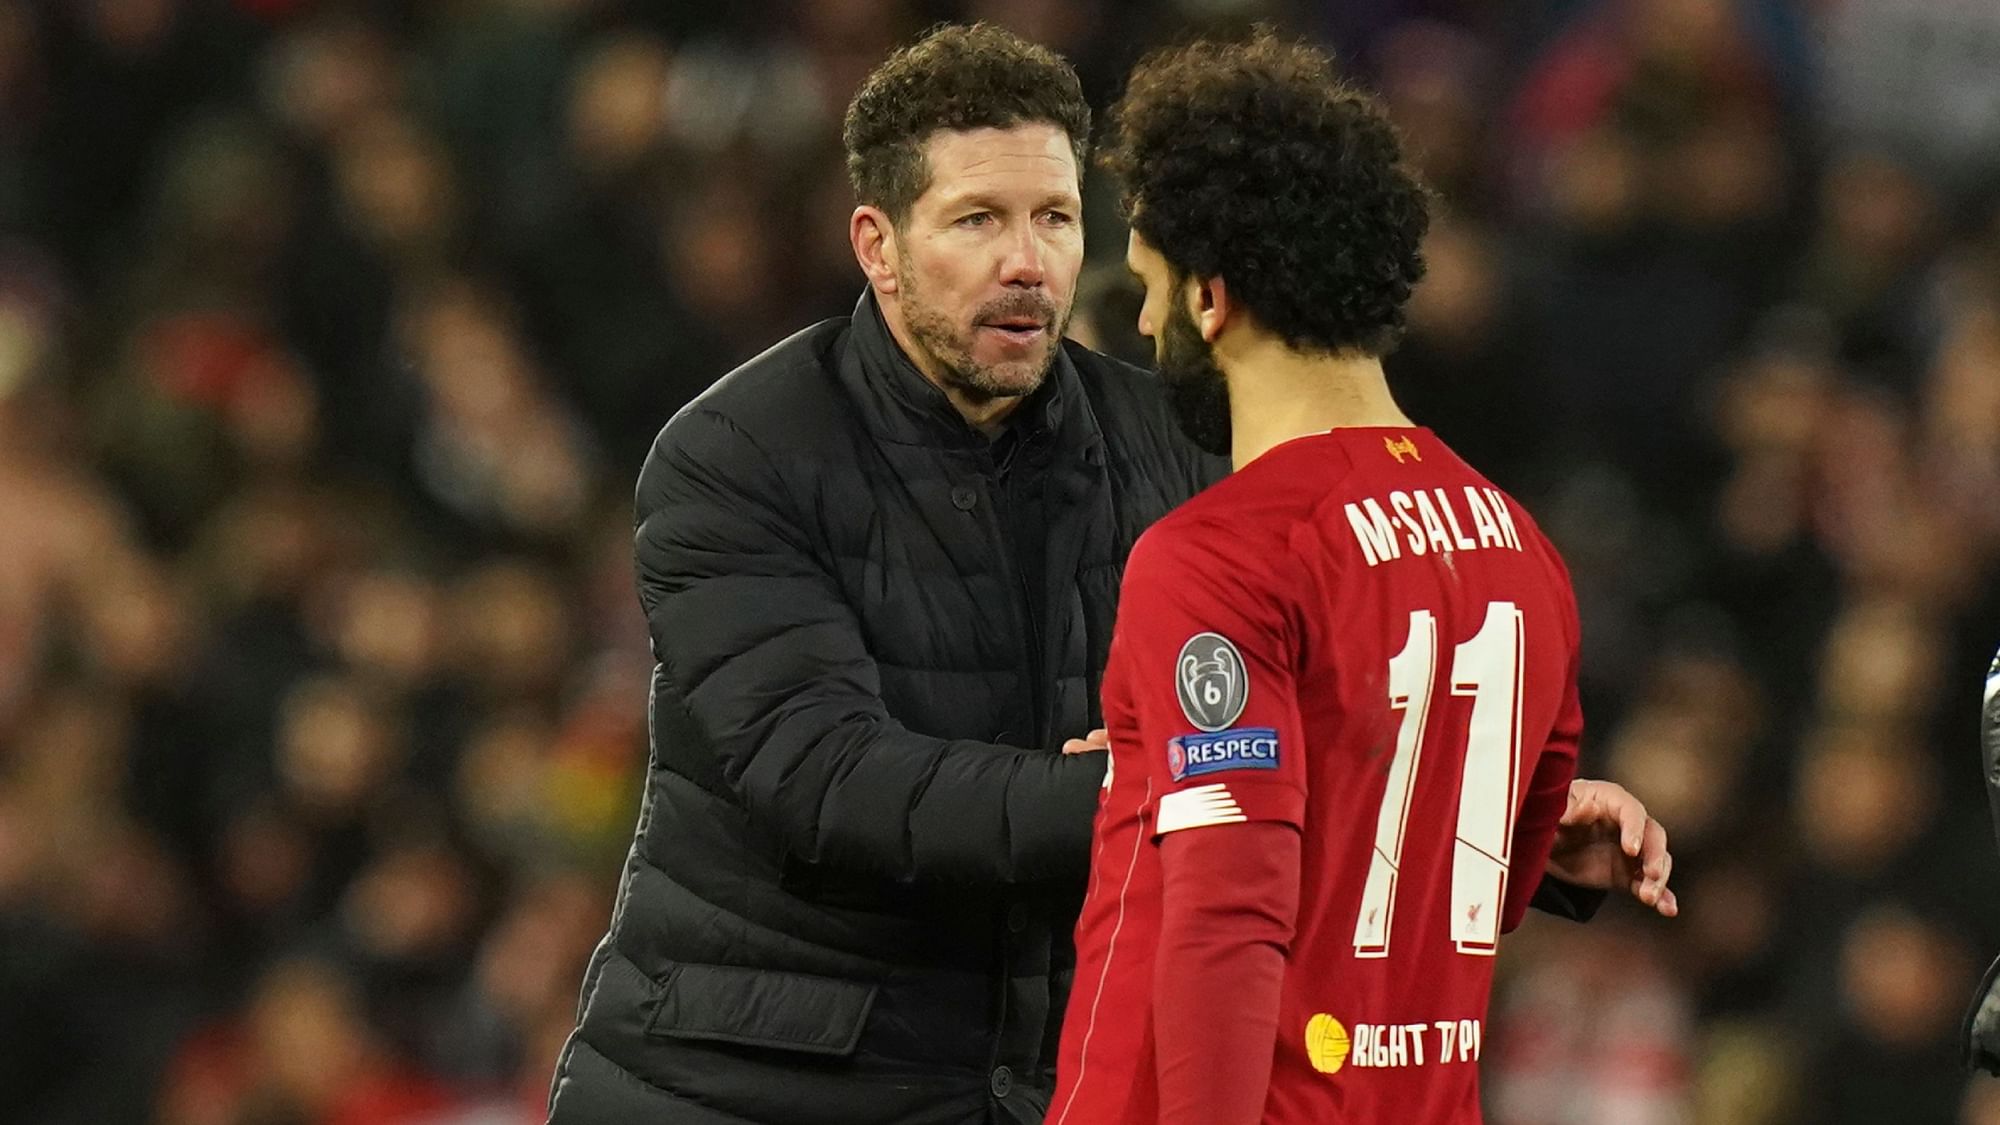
[1548,779,1680,919]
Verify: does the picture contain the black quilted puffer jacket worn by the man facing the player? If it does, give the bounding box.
[552,298,1222,1125]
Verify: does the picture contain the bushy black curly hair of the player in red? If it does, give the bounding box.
[1102,28,1430,356]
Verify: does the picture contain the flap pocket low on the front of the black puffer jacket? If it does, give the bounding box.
[646,965,876,1057]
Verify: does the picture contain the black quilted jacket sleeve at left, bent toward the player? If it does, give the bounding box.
[636,406,1104,885]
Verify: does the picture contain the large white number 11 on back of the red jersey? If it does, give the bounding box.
[1354,603,1522,957]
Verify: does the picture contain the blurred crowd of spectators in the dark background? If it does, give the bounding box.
[0,0,2000,1125]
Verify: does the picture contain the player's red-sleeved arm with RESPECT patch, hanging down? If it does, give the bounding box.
[1122,524,1306,1125]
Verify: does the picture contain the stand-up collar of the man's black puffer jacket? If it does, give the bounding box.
[840,290,1082,448]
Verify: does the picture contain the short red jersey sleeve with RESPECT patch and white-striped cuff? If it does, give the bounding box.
[1118,524,1306,839]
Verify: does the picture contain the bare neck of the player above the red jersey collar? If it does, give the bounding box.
[1216,332,1410,468]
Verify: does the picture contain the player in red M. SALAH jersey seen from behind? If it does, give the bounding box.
[1048,36,1640,1125]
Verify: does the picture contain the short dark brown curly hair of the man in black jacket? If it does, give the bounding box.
[842,24,1090,222]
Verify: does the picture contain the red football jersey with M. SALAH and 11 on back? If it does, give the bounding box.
[1048,426,1582,1125]
